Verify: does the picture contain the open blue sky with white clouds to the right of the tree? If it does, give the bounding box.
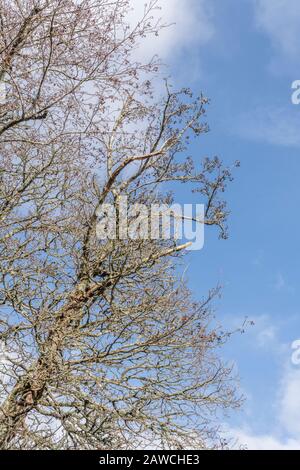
[133,0,300,449]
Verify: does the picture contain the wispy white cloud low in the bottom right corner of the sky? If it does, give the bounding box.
[228,314,300,450]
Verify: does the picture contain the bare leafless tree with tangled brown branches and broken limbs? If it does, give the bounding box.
[0,0,238,449]
